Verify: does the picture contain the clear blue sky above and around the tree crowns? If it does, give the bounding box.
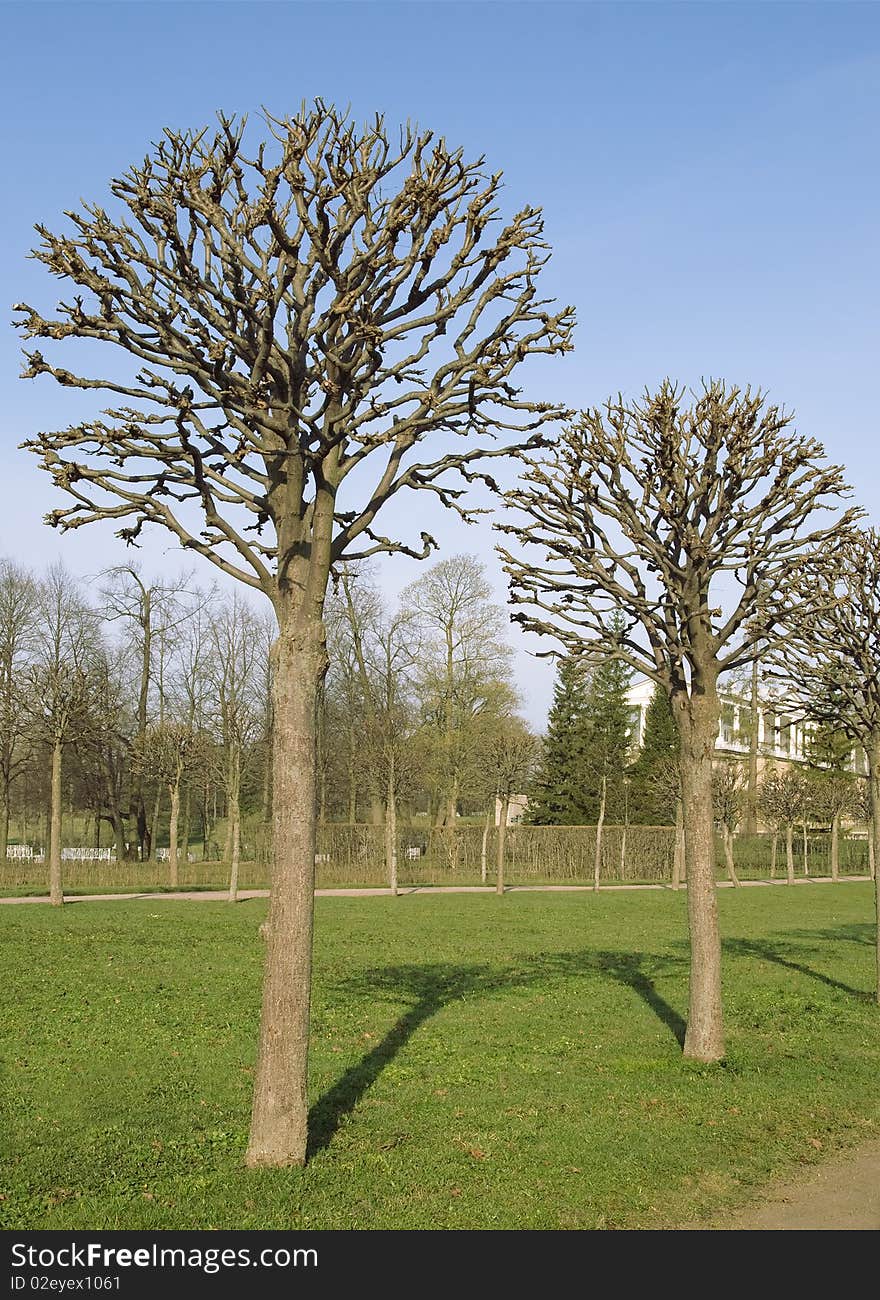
[0,0,880,725]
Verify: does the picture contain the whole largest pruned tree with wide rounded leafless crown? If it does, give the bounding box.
[18,100,573,1165]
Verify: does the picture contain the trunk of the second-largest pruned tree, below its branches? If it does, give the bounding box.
[673,681,724,1061]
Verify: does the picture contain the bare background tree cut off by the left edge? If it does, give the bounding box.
[0,559,36,865]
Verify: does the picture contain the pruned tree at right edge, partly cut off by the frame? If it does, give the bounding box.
[775,528,880,1001]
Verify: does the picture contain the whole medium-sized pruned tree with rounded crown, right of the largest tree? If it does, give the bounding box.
[498,381,845,1061]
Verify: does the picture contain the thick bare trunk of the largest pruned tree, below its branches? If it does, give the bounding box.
[246,615,326,1167]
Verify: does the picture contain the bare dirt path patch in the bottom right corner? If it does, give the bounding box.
[699,1141,880,1232]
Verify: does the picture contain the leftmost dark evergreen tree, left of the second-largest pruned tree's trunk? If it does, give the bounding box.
[525,655,586,826]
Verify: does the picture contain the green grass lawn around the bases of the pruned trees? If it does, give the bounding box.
[0,884,880,1229]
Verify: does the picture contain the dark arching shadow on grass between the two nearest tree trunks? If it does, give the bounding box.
[307,950,686,1158]
